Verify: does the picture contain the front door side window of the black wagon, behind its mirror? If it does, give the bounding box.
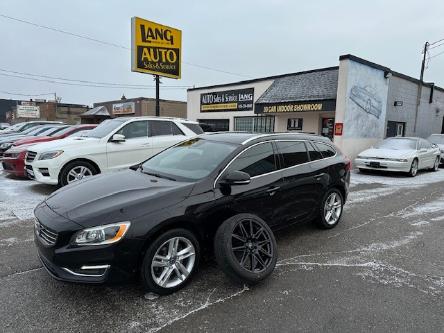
[226,142,276,177]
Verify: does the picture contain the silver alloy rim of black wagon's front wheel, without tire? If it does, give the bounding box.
[151,237,196,288]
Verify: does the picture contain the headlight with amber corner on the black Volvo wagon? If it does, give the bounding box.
[73,222,131,245]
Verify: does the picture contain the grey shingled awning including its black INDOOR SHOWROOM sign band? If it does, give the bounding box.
[254,67,339,113]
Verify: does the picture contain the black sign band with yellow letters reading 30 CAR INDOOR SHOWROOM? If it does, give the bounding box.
[254,99,336,113]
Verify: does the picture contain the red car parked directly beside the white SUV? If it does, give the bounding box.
[2,125,97,178]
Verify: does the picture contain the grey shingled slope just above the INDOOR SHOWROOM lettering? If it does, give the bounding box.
[256,68,339,104]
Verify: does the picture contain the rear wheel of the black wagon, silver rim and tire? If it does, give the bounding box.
[317,188,344,229]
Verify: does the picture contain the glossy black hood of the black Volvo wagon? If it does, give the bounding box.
[46,170,194,227]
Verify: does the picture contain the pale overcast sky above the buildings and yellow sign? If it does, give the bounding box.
[0,0,444,104]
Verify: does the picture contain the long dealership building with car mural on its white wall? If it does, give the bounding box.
[187,55,444,157]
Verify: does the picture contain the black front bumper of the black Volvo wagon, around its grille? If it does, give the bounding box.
[34,204,143,284]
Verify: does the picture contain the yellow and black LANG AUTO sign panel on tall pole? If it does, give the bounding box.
[131,17,182,79]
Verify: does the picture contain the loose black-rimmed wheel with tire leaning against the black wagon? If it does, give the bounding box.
[214,214,277,284]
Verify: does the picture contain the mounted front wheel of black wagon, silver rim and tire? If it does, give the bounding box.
[141,229,200,295]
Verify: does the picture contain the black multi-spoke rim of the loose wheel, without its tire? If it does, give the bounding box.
[231,219,274,273]
